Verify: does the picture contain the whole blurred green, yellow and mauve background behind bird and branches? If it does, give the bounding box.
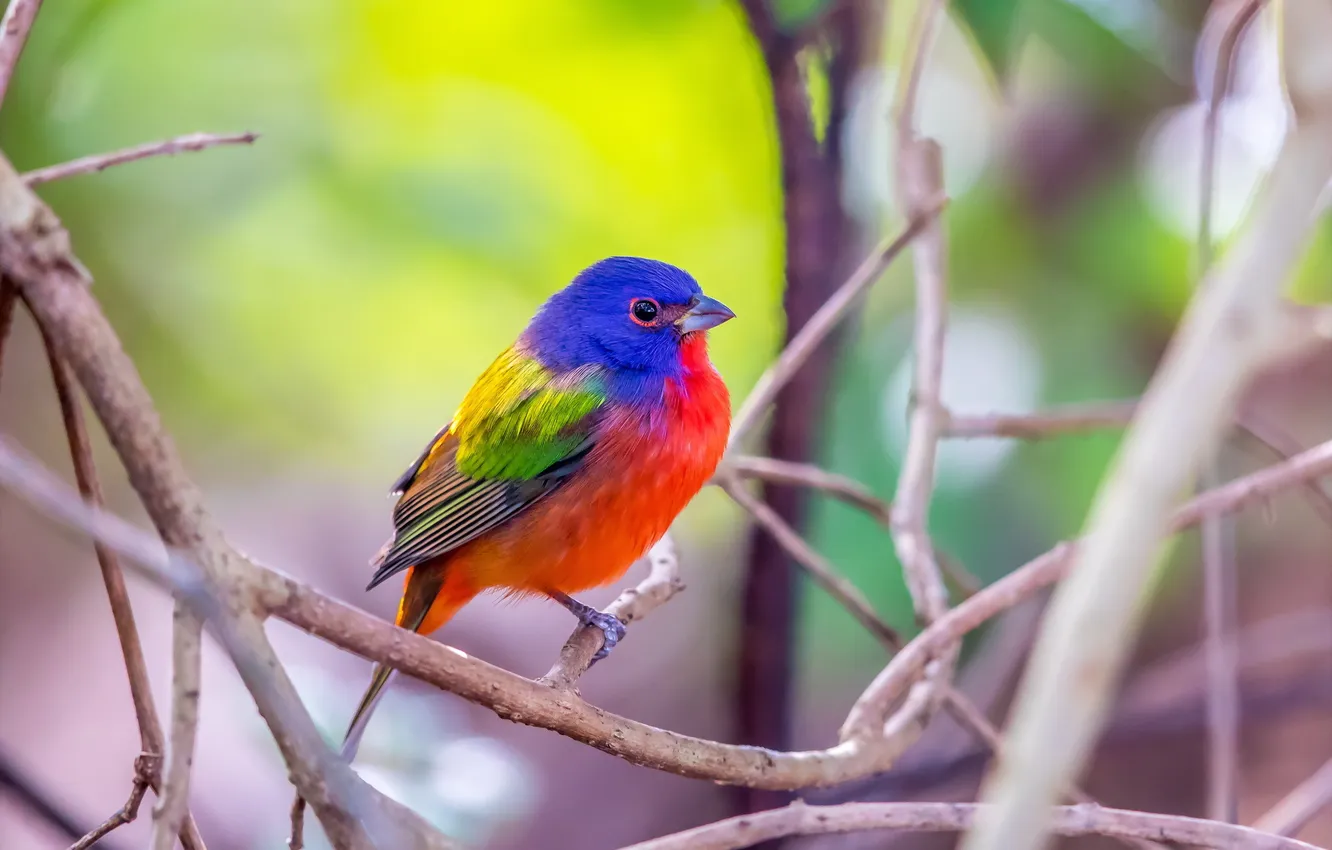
[0,0,1332,850]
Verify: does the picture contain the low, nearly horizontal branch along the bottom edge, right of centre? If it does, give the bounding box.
[622,802,1317,850]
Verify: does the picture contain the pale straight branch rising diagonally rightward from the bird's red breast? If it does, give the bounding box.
[729,199,946,449]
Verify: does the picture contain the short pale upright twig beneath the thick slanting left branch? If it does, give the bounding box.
[152,610,204,850]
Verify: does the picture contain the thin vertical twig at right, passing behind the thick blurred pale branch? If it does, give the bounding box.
[1196,0,1261,823]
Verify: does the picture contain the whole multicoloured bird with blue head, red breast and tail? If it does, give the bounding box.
[342,257,735,758]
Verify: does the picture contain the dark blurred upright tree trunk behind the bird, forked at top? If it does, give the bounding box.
[735,0,879,826]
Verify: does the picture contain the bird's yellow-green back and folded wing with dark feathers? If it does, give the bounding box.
[369,349,606,588]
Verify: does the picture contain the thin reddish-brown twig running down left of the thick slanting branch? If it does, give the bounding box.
[39,328,204,850]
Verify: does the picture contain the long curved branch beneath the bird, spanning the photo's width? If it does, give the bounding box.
[0,415,1332,804]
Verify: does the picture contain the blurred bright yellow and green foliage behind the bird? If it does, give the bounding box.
[0,0,1332,746]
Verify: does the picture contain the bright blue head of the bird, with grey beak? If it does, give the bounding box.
[522,257,735,389]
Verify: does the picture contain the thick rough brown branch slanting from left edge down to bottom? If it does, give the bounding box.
[0,157,445,847]
